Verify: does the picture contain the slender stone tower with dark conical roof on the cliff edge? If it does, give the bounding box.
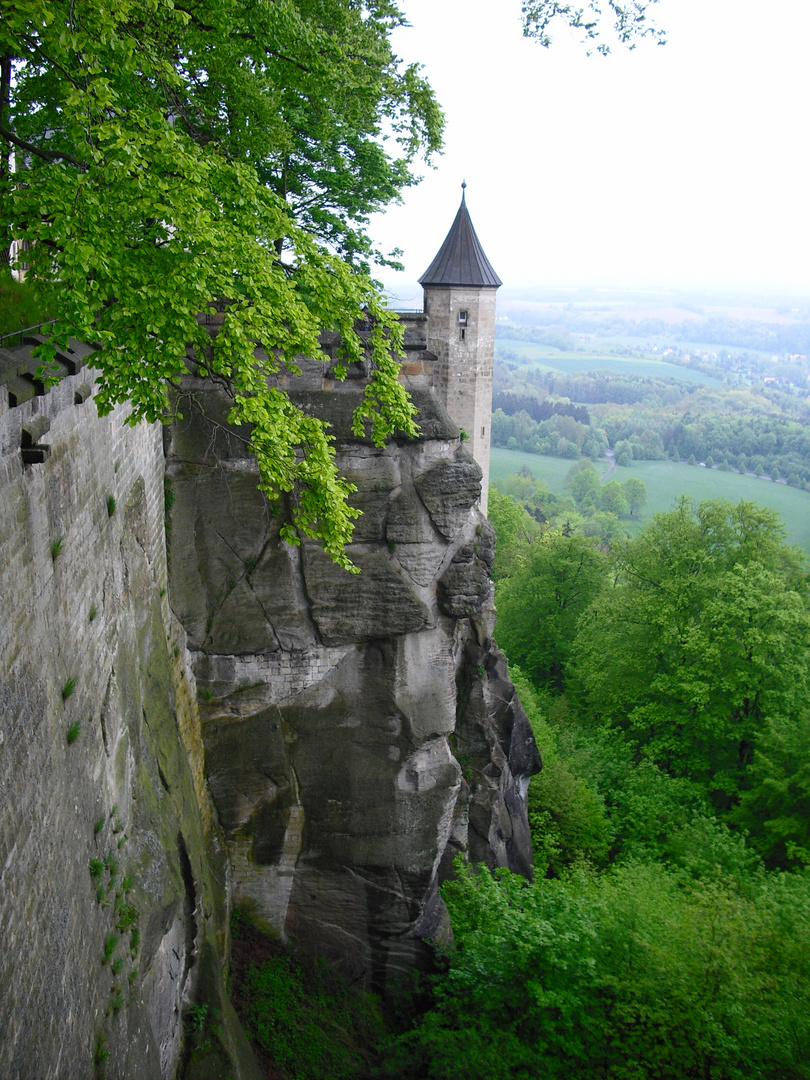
[419,184,501,514]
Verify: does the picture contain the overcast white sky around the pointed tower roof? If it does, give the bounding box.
[373,0,810,306]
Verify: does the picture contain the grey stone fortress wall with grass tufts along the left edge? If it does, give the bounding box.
[0,336,257,1080]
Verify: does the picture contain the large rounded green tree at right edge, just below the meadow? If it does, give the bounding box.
[575,500,810,808]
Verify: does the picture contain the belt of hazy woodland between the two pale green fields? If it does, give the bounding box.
[492,352,810,487]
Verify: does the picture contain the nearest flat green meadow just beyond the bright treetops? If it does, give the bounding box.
[490,446,810,557]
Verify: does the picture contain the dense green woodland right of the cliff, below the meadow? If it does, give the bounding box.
[384,490,810,1080]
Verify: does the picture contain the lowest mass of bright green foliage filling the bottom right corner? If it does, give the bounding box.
[389,863,810,1080]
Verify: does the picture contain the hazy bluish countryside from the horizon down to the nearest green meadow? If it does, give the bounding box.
[492,309,810,488]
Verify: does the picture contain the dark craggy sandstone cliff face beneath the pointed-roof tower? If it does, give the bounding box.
[166,379,538,988]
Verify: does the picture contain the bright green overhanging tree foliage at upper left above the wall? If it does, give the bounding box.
[0,0,442,564]
